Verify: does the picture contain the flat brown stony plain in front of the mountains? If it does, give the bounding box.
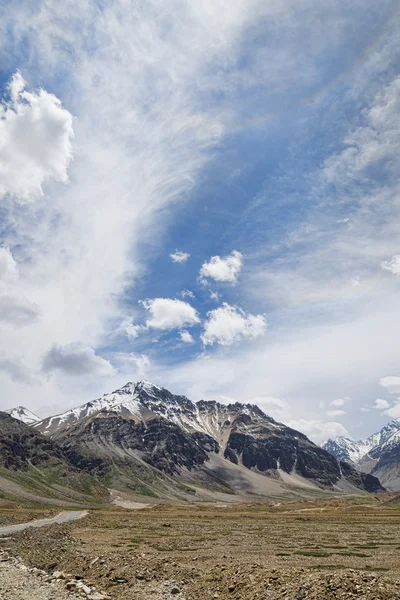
[7,497,400,600]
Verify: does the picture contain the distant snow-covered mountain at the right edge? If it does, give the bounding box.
[322,419,400,490]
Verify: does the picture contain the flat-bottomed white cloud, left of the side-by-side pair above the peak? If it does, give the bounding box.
[142,298,200,331]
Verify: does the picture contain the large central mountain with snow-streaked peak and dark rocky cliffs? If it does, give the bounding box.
[34,381,382,497]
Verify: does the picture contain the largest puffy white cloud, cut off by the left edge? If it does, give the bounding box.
[0,72,74,202]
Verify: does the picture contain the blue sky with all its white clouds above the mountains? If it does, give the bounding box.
[0,0,400,443]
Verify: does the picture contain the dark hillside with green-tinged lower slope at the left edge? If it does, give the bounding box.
[0,412,108,506]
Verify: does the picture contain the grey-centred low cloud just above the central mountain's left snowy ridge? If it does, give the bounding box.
[43,343,115,376]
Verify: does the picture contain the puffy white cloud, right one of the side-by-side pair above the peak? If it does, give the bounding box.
[201,302,267,346]
